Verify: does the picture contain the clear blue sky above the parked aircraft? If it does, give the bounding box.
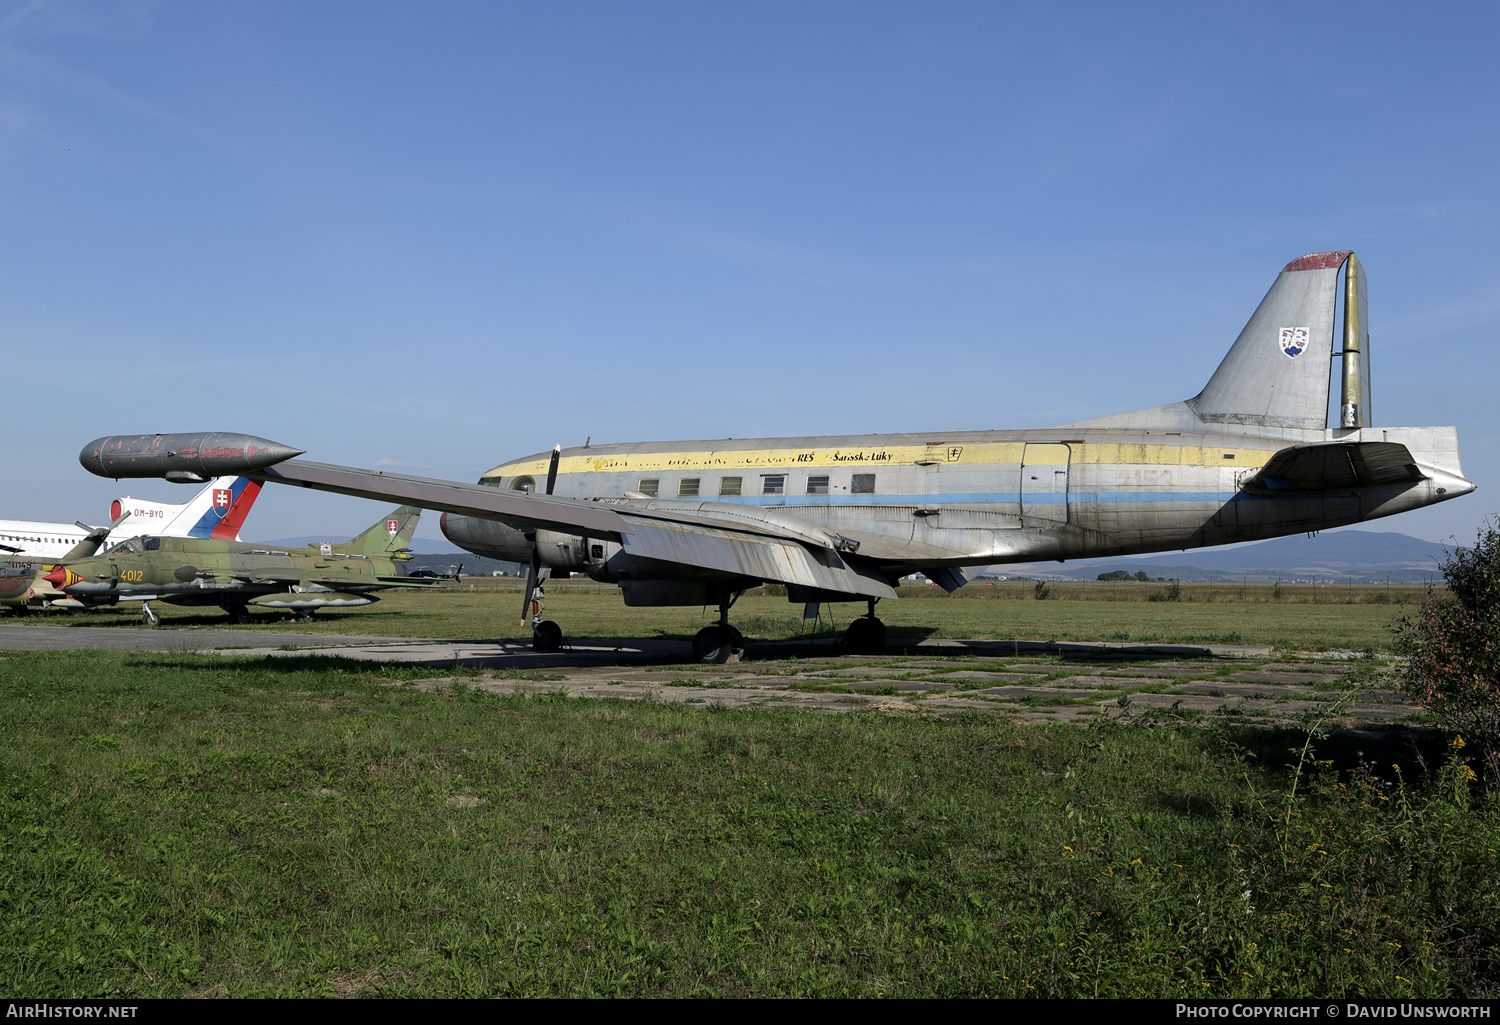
[0,0,1500,540]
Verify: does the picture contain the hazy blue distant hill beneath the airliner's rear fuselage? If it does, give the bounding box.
[992,530,1448,584]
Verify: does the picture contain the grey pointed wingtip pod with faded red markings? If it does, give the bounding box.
[78,432,303,482]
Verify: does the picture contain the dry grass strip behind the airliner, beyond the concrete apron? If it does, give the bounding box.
[0,584,1419,651]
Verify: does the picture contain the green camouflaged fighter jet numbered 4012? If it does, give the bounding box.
[45,506,432,626]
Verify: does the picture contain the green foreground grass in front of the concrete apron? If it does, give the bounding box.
[0,654,1500,998]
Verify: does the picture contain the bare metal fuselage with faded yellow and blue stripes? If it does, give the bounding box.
[444,414,1473,597]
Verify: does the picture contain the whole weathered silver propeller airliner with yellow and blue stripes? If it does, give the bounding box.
[78,251,1475,662]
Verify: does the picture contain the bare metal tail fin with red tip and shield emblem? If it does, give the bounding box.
[1188,251,1371,431]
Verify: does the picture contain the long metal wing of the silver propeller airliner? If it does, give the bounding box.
[248,459,896,597]
